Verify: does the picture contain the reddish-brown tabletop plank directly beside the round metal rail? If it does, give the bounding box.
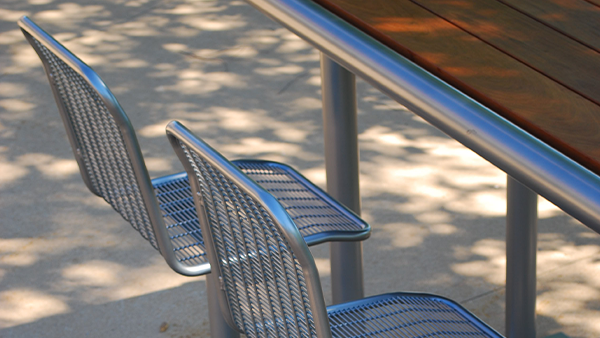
[315,0,600,174]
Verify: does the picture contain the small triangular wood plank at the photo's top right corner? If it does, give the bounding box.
[498,0,600,52]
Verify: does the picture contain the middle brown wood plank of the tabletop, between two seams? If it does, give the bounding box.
[413,0,600,104]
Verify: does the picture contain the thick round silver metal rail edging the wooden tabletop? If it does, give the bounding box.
[240,0,600,232]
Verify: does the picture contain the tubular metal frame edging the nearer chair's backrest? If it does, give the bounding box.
[167,121,331,338]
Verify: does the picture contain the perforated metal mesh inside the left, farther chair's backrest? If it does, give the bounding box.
[31,37,158,248]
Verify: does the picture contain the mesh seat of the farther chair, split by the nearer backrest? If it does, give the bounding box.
[152,160,369,266]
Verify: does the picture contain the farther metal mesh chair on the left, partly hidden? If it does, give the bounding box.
[19,17,370,276]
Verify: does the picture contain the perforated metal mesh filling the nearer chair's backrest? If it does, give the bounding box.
[181,144,316,337]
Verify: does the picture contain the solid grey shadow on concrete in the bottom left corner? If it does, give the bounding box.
[2,282,210,338]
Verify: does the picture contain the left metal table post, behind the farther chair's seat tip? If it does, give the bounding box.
[321,54,364,304]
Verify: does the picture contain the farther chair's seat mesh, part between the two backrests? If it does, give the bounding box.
[154,175,208,266]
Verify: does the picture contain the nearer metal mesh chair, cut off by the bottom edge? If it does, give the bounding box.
[167,121,501,338]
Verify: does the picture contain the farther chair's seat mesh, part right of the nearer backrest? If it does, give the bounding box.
[235,161,367,237]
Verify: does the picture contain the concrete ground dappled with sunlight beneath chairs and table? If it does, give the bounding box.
[0,0,600,338]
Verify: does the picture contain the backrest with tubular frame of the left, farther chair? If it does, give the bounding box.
[19,17,198,275]
